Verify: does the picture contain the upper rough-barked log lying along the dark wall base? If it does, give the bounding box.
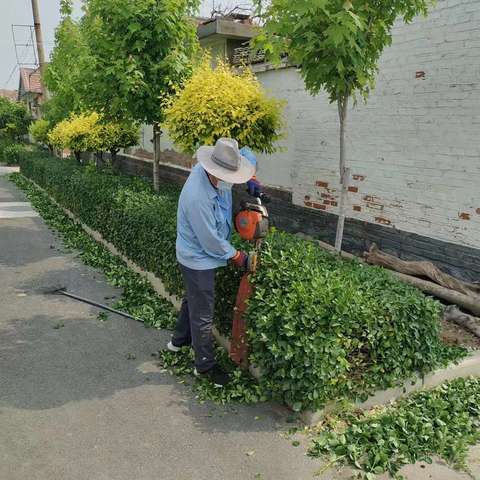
[364,244,480,296]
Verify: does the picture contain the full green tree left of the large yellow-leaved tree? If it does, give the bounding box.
[83,0,198,190]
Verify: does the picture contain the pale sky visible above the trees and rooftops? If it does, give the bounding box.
[0,0,253,89]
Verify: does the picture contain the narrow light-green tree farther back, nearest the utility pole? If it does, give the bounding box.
[42,0,91,125]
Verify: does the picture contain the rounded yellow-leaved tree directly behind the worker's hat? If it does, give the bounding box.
[163,56,283,153]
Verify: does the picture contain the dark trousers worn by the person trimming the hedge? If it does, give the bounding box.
[172,265,215,373]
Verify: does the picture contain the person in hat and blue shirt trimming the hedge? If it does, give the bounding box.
[167,138,261,386]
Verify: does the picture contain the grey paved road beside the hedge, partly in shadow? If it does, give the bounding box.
[0,172,480,480]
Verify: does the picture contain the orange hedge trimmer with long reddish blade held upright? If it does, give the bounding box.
[230,194,269,368]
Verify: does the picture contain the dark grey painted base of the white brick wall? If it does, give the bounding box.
[113,155,480,281]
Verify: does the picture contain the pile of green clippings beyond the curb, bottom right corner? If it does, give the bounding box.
[309,378,480,480]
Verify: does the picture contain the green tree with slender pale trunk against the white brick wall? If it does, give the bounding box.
[255,0,432,251]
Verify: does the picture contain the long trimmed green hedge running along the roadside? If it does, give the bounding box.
[21,154,465,410]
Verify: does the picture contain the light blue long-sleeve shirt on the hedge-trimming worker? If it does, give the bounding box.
[176,164,236,270]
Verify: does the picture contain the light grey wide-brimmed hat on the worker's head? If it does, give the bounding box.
[197,138,255,183]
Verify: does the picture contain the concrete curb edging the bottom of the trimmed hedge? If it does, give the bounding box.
[25,177,480,426]
